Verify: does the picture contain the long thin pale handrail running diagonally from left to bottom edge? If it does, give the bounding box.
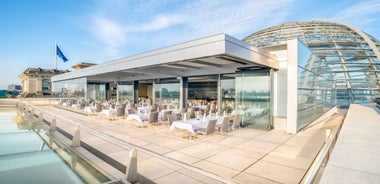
[20,101,235,184]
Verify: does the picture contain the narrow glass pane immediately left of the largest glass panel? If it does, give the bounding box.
[220,73,236,115]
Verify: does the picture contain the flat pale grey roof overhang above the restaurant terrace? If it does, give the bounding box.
[52,34,278,82]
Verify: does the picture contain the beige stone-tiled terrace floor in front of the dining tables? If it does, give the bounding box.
[23,106,344,183]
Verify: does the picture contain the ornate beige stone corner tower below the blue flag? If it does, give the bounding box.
[18,68,69,97]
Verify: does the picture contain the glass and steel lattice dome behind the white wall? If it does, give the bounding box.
[243,19,380,105]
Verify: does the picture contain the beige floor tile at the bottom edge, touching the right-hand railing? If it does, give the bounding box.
[244,161,305,184]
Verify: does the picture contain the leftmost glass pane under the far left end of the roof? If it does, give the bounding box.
[53,77,87,99]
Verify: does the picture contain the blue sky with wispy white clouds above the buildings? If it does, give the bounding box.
[0,0,380,89]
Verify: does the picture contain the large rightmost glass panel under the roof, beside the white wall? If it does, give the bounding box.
[232,69,272,130]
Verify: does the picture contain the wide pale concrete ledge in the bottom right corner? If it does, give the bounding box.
[320,104,380,183]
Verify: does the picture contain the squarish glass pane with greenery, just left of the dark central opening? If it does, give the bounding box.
[153,79,180,108]
